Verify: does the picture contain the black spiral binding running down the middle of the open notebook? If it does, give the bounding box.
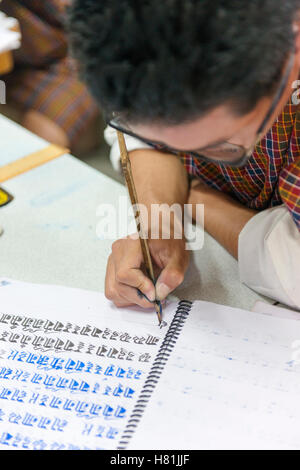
[117,300,192,450]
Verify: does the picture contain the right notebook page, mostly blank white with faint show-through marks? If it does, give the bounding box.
[128,302,300,449]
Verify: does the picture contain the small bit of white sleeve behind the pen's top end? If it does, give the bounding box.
[104,126,152,173]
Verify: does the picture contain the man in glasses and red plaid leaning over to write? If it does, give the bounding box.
[69,0,300,308]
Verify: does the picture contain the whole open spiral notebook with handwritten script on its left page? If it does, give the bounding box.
[0,279,300,450]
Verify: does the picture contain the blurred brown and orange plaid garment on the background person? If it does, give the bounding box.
[1,0,99,146]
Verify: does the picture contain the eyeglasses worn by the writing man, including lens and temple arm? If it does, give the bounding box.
[106,52,295,167]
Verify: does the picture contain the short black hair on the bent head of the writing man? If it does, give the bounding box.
[68,0,300,124]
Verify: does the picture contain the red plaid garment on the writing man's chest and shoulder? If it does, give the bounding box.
[182,98,300,230]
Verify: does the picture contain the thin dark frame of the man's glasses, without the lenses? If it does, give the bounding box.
[106,51,295,168]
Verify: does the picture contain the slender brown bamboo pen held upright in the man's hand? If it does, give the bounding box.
[117,131,162,325]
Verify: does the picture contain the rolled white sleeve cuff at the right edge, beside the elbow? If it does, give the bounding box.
[238,205,300,309]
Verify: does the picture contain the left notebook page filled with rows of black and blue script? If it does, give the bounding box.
[0,279,174,450]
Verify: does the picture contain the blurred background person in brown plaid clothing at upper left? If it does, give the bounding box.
[0,0,101,154]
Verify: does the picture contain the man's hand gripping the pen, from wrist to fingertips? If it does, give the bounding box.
[105,236,189,308]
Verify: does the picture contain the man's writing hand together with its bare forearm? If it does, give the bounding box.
[105,149,189,308]
